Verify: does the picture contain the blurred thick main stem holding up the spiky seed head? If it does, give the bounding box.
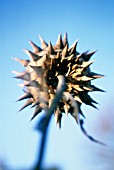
[34,75,66,170]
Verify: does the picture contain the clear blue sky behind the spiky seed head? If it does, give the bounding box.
[0,0,114,170]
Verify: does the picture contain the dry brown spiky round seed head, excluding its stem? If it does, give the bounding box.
[14,33,103,127]
